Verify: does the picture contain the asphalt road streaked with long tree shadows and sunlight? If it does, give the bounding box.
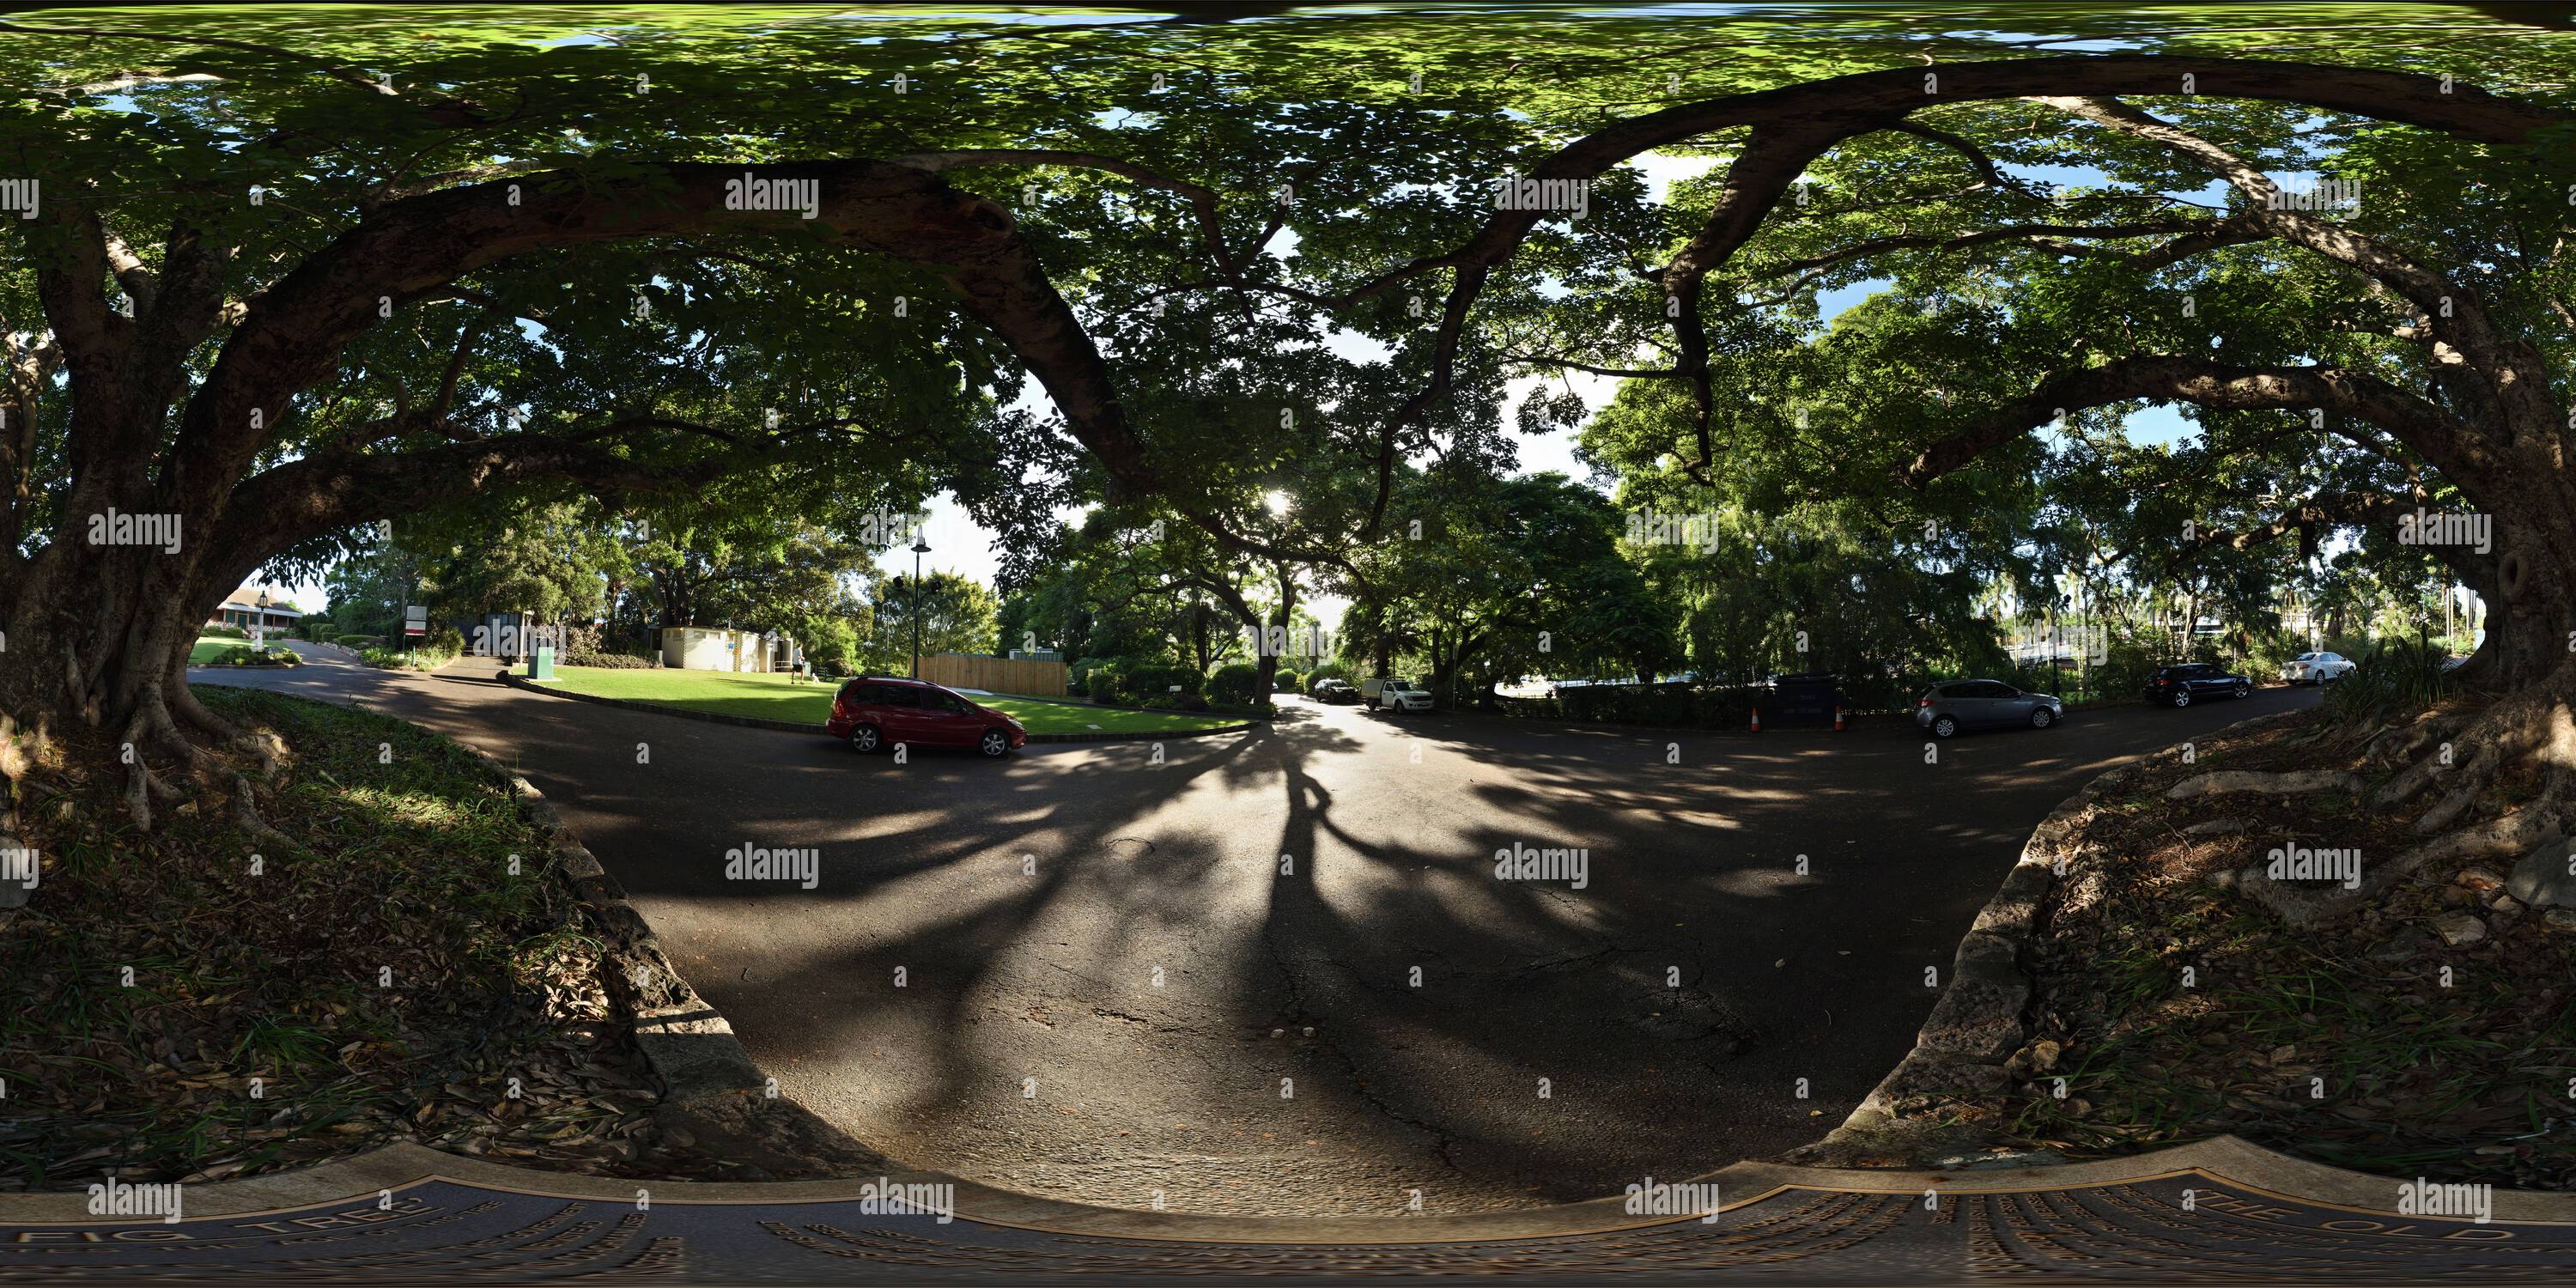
[191,649,2316,1216]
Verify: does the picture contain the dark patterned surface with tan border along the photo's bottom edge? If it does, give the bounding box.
[0,1139,2576,1283]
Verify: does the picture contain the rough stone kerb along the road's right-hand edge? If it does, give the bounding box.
[1785,711,2306,1167]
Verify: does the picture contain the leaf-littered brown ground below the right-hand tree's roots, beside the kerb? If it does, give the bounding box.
[1937,711,2576,1188]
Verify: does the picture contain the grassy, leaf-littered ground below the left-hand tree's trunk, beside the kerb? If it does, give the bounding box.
[0,685,845,1190]
